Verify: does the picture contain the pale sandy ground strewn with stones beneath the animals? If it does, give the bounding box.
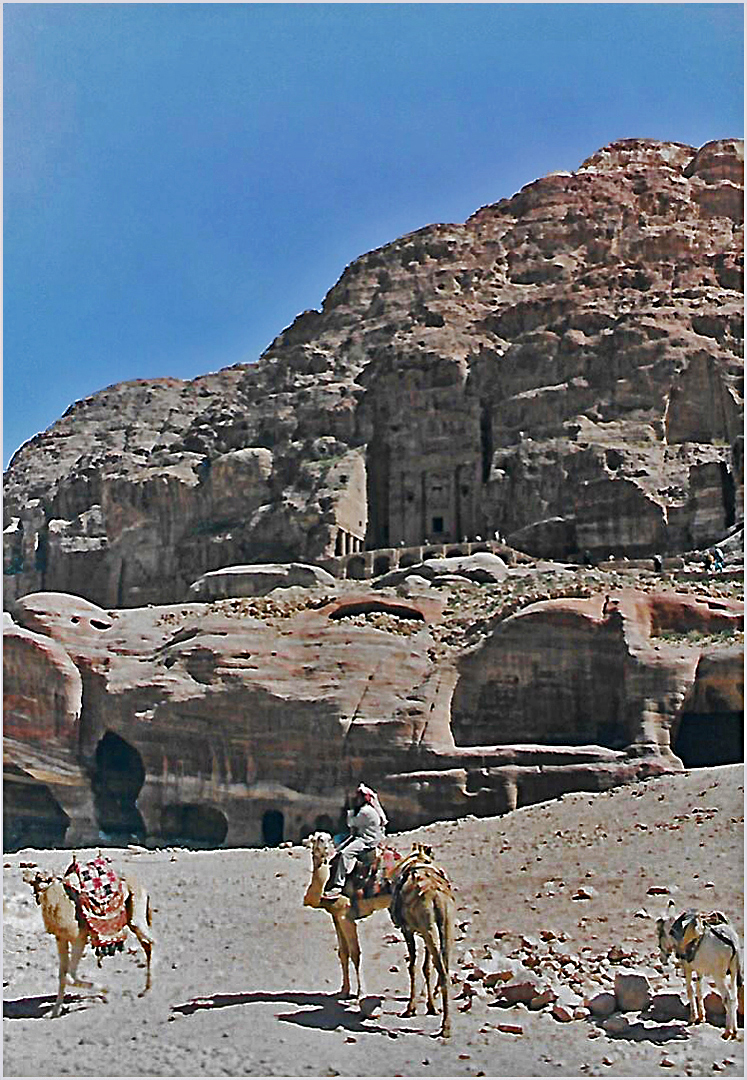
[3,766,744,1077]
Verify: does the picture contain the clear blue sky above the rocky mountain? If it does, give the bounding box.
[3,3,744,463]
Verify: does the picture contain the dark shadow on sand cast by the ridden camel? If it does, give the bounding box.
[172,990,429,1038]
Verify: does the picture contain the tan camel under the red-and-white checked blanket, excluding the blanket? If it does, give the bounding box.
[24,868,153,1016]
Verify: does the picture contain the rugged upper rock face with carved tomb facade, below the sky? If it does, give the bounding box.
[4,139,744,608]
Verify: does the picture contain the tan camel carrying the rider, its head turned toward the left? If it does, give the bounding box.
[303,833,399,998]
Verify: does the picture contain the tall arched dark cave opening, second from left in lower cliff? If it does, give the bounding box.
[91,731,146,841]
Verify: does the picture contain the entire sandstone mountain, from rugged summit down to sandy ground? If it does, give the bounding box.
[3,139,744,848]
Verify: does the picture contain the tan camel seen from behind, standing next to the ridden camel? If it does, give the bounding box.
[390,843,457,1039]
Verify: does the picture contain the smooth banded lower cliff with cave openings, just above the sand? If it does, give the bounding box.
[3,583,744,848]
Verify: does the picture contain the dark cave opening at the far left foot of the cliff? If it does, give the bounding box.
[2,766,70,851]
